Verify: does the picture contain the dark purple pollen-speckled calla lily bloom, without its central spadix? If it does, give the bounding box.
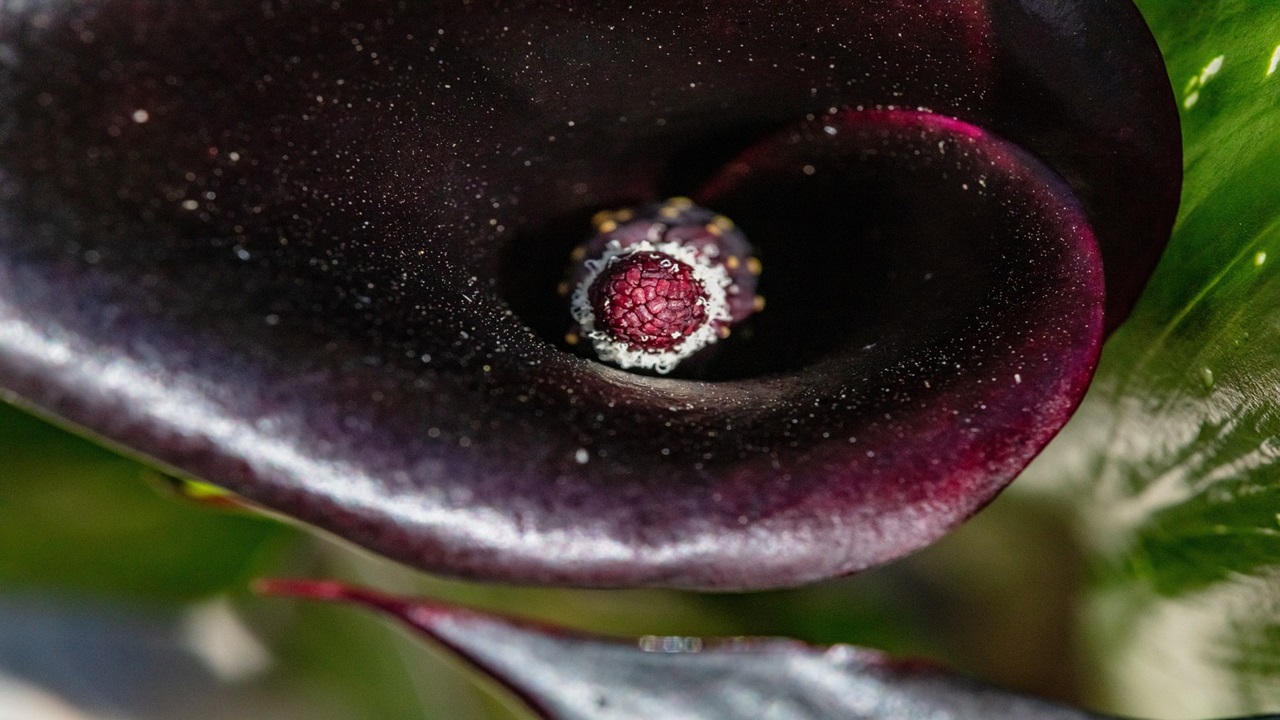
[0,0,1181,588]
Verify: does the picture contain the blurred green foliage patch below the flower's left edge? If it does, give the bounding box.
[0,404,296,601]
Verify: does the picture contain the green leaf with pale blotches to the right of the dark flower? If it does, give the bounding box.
[1029,0,1280,716]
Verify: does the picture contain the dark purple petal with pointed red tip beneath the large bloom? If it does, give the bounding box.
[261,580,1131,720]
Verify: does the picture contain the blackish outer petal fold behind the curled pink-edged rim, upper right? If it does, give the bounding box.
[977,0,1183,326]
